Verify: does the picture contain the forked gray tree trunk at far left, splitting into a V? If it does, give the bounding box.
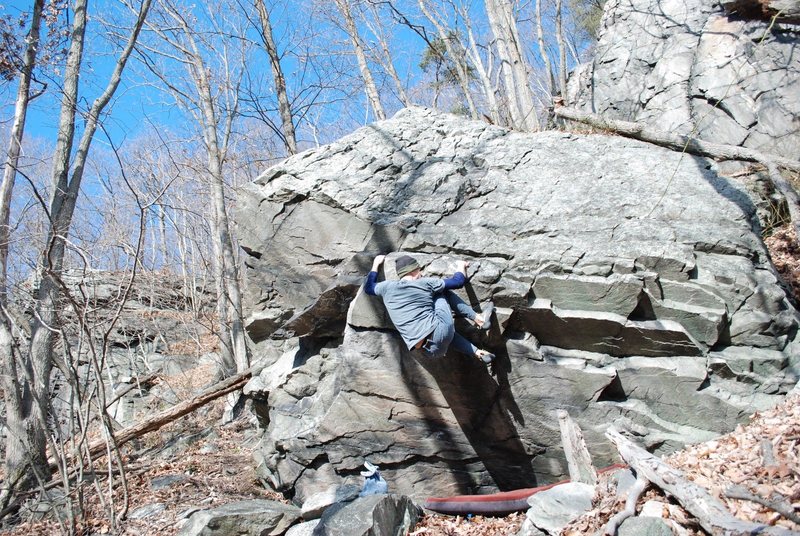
[7,0,150,506]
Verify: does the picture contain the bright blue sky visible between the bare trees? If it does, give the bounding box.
[0,0,592,157]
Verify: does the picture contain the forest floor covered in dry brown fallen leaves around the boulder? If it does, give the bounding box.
[0,227,800,536]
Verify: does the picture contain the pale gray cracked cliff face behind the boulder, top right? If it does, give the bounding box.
[569,0,800,158]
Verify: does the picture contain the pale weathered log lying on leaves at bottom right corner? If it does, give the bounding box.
[606,428,797,536]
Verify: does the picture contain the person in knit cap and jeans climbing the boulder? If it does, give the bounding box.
[364,255,494,364]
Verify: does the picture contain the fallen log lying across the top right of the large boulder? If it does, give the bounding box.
[553,107,800,241]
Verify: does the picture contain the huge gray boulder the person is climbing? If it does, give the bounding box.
[237,108,798,504]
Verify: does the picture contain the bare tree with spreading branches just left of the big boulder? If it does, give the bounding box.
[139,0,250,376]
